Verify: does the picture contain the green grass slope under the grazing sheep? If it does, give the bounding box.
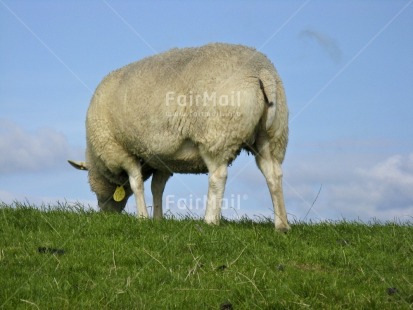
[0,203,413,309]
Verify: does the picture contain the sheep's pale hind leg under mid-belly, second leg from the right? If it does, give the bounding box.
[202,151,227,225]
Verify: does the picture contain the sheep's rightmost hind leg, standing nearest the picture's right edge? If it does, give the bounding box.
[255,142,290,232]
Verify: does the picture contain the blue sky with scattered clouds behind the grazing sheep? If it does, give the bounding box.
[0,0,413,221]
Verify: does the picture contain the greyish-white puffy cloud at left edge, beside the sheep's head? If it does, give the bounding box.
[0,119,81,174]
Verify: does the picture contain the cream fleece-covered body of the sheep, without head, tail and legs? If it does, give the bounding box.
[87,44,287,173]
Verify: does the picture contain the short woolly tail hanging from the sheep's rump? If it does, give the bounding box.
[259,69,277,131]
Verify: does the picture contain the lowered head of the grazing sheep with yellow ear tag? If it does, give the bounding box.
[69,160,132,212]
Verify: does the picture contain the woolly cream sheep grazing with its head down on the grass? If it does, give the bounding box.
[69,43,290,231]
